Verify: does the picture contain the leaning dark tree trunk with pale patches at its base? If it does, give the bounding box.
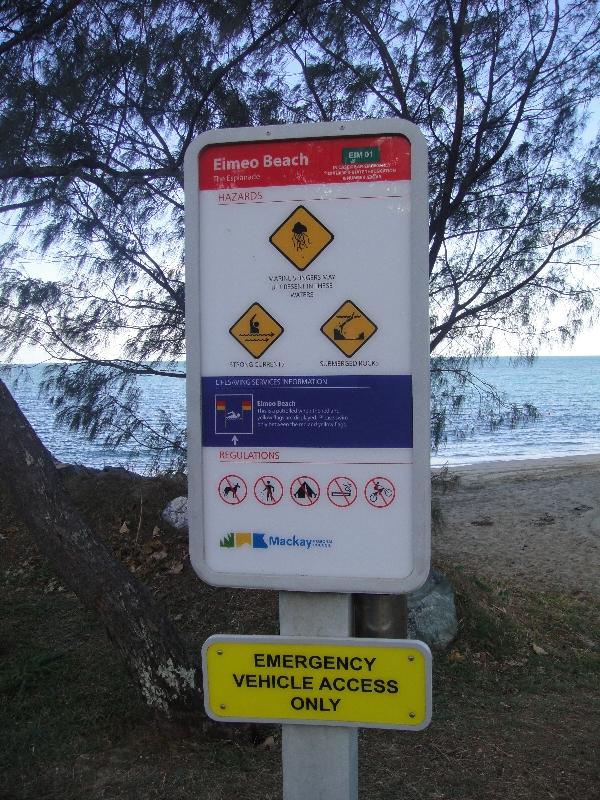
[0,381,205,725]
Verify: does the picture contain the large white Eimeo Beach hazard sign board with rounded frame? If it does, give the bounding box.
[185,120,430,593]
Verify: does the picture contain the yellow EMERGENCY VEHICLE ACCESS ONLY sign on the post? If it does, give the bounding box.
[202,636,431,730]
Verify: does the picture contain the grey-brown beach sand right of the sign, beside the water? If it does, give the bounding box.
[432,455,600,592]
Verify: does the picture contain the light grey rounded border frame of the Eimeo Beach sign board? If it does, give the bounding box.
[185,119,431,594]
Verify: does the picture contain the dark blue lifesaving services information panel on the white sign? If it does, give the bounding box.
[202,375,413,448]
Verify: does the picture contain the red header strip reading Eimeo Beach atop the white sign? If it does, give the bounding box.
[198,134,410,189]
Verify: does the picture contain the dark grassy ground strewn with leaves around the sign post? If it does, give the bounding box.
[0,506,600,800]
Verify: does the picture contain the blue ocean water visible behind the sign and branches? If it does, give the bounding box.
[2,356,600,473]
